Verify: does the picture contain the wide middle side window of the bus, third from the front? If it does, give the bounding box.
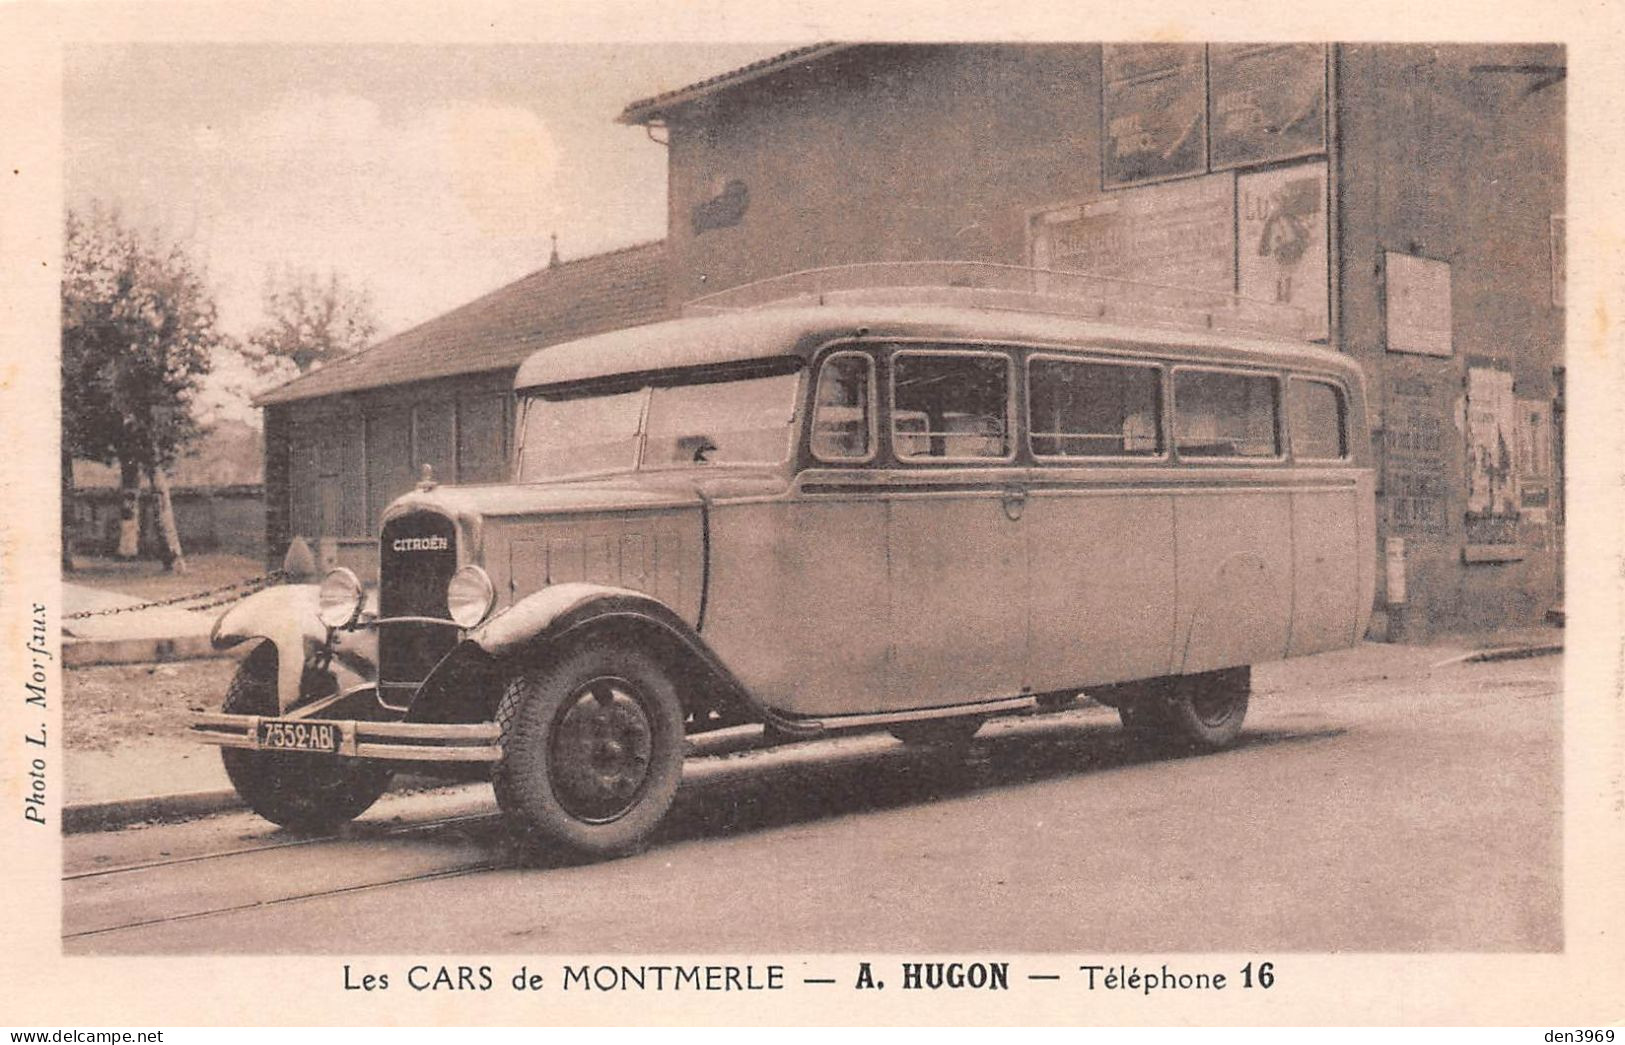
[1027,359,1162,457]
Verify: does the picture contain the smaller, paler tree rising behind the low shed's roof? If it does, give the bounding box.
[247,268,379,374]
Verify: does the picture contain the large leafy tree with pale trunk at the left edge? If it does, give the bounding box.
[62,206,226,572]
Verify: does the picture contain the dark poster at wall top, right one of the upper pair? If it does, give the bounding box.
[1207,44,1326,171]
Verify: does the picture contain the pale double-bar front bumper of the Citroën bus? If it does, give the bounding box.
[192,713,502,762]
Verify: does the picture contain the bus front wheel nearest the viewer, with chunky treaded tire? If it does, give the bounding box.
[491,642,684,858]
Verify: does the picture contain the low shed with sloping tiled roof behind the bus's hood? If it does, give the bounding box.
[257,242,670,577]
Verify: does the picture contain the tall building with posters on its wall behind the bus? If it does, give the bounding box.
[621,44,1565,634]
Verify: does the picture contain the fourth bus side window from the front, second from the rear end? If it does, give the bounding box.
[1173,369,1281,457]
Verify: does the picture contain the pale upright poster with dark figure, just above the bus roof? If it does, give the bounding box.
[1237,161,1331,338]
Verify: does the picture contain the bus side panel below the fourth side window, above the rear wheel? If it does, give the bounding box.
[1173,487,1292,673]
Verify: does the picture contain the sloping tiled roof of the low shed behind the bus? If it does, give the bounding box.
[255,242,673,406]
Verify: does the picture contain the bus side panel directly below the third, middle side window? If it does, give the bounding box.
[1022,481,1175,692]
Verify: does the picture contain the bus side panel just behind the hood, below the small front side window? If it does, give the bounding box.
[702,494,891,715]
